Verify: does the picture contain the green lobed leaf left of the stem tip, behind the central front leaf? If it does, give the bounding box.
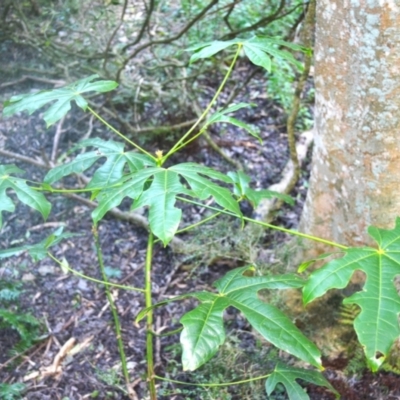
[44,138,155,189]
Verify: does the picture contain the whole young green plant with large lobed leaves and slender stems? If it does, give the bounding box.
[0,37,400,400]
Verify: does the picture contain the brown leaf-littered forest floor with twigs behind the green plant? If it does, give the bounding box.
[0,63,400,400]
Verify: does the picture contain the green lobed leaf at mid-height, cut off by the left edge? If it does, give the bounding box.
[0,165,51,227]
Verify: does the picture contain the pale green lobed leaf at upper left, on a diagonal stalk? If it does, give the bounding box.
[3,75,118,127]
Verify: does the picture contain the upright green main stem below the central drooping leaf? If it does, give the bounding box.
[144,231,157,400]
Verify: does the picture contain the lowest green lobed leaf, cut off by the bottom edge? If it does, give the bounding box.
[265,362,340,400]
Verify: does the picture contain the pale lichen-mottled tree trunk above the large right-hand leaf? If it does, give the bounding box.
[300,0,400,252]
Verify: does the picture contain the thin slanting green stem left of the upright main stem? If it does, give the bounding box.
[92,224,130,393]
